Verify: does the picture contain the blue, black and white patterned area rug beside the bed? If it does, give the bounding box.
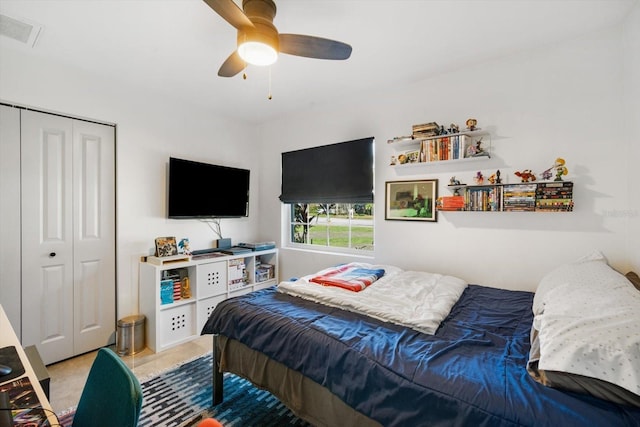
[58,353,310,427]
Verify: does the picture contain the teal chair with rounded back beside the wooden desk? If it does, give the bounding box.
[73,348,142,427]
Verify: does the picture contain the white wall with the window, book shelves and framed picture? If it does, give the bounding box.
[261,21,638,290]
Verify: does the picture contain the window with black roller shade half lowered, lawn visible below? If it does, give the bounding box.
[280,138,374,252]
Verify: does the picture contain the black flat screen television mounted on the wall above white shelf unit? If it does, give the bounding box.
[167,157,250,219]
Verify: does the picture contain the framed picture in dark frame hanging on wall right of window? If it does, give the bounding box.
[384,179,438,222]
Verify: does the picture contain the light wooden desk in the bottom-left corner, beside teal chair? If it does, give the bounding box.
[0,305,58,425]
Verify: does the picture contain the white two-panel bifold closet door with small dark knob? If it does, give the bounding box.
[21,110,116,364]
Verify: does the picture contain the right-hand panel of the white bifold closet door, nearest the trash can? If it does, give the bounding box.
[73,120,116,354]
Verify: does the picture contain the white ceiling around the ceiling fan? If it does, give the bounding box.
[0,0,637,122]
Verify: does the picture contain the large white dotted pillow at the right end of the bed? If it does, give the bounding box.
[533,253,640,402]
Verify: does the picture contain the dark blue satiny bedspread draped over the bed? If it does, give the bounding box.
[202,285,640,427]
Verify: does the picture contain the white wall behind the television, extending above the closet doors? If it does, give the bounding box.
[0,49,261,318]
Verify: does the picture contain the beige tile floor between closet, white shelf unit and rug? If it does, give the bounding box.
[47,335,213,413]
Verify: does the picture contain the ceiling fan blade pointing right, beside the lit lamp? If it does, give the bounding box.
[279,34,351,59]
